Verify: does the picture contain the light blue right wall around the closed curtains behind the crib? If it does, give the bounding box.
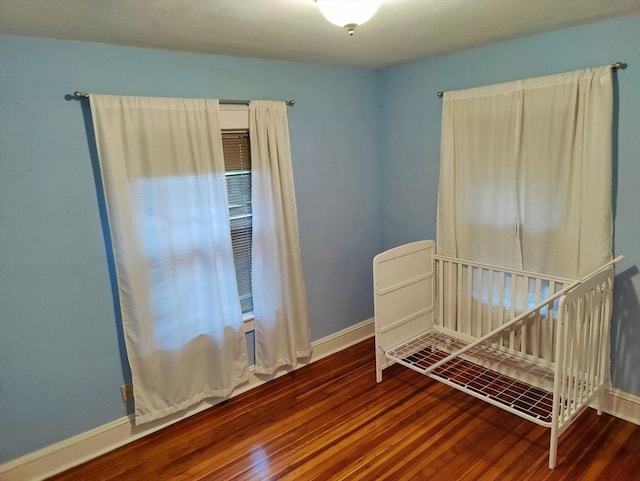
[379,15,640,395]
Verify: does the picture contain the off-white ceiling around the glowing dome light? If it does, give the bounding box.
[0,0,640,68]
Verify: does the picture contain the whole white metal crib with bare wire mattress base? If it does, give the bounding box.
[373,241,620,468]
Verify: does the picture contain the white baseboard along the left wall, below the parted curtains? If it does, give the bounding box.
[0,319,373,481]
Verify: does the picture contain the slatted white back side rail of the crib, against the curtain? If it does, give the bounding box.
[436,255,573,363]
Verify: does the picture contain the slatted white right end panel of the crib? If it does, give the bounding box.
[554,267,613,428]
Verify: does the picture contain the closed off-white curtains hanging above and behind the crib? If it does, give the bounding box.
[437,66,613,278]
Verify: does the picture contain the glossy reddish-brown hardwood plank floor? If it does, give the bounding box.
[51,340,640,481]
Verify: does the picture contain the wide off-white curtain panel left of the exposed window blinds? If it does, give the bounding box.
[90,95,248,423]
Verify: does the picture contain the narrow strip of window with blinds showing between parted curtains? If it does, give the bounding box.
[222,130,253,314]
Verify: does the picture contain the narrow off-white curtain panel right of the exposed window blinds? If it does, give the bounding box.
[249,101,311,375]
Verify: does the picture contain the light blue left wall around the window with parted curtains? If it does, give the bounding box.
[0,36,381,462]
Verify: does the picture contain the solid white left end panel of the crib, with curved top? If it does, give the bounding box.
[373,240,436,382]
